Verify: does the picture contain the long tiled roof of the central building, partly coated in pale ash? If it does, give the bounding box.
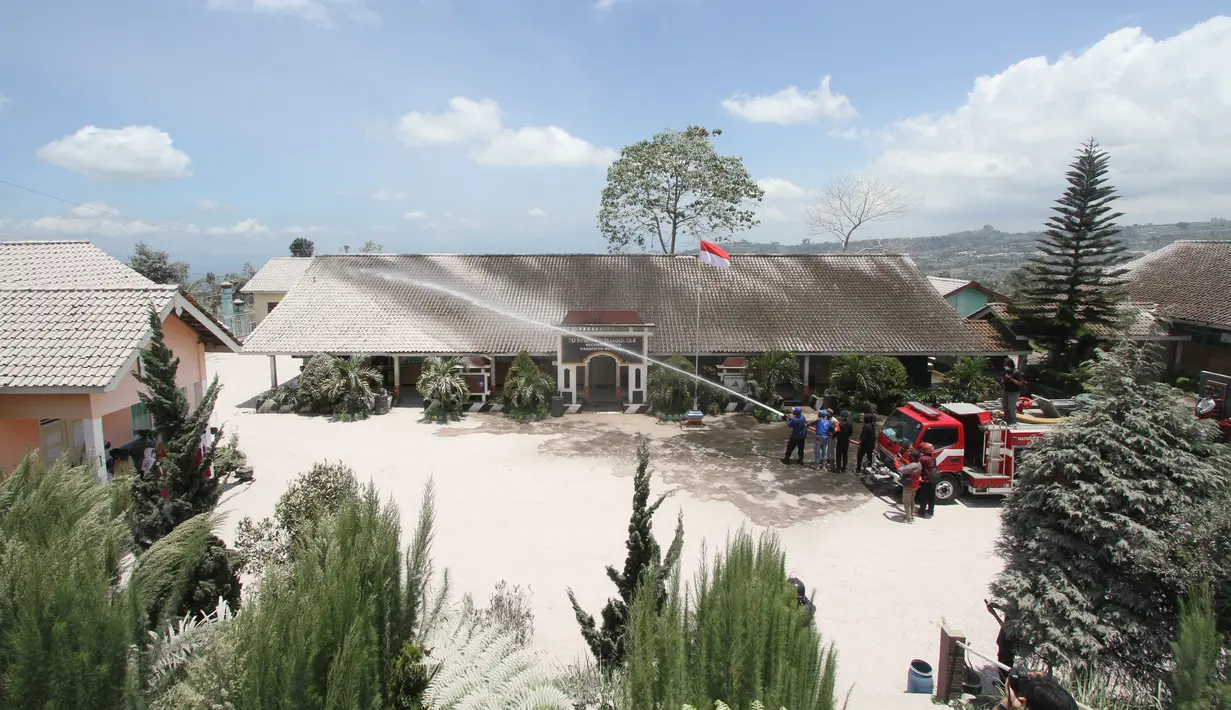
[244,255,999,354]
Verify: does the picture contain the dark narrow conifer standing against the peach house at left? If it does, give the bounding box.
[133,309,222,546]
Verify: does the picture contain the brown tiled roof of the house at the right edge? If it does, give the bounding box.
[1125,240,1231,327]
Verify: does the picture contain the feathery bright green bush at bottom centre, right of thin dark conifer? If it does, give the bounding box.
[624,529,837,710]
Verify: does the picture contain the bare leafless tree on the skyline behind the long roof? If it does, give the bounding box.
[804,177,916,251]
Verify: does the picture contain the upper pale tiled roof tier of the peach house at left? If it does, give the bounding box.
[0,241,154,288]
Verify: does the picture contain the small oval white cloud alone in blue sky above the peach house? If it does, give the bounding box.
[34,126,192,181]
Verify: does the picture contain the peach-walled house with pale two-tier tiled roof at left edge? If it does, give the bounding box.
[0,241,239,477]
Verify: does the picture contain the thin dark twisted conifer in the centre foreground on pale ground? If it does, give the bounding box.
[569,439,684,671]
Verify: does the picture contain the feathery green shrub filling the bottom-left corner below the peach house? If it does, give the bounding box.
[0,455,232,709]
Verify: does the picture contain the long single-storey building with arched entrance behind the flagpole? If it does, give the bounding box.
[237,253,1019,406]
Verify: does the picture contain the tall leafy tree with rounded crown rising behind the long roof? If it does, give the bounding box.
[598,126,764,253]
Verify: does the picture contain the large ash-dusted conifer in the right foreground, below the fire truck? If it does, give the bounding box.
[992,342,1231,679]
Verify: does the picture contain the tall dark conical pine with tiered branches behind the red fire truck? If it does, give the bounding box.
[1013,138,1124,365]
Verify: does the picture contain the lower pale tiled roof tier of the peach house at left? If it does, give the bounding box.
[0,285,177,388]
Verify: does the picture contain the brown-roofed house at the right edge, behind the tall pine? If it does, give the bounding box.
[1125,240,1231,374]
